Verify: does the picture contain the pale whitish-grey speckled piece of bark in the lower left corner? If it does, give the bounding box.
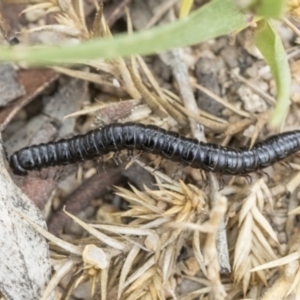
[0,137,54,300]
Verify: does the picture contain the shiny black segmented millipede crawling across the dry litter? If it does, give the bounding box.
[10,123,300,175]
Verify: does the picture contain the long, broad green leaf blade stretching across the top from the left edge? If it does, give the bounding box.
[0,0,246,65]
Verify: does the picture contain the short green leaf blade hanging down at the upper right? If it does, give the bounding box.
[254,20,291,126]
